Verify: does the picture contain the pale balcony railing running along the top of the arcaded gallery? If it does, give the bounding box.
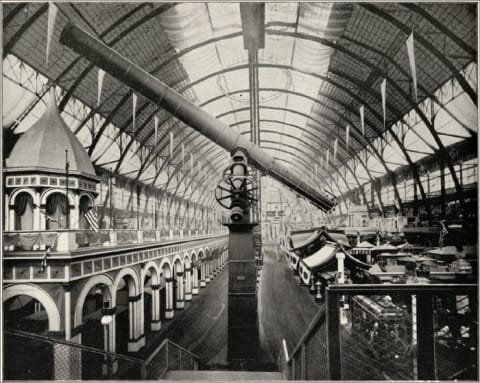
[3,227,226,252]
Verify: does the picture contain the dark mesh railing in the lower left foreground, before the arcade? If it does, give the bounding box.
[3,329,199,380]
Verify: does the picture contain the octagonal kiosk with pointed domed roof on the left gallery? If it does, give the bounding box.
[5,88,99,243]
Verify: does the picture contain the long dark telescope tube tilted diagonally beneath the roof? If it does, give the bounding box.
[60,22,335,211]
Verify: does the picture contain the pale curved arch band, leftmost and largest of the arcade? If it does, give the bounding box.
[2,283,61,331]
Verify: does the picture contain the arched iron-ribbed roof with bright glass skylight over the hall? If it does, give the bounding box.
[4,3,477,210]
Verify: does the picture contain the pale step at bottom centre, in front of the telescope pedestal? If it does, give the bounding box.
[163,370,284,382]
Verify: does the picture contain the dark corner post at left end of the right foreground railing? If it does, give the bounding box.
[326,288,342,380]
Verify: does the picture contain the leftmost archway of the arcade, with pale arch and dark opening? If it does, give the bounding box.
[3,285,60,380]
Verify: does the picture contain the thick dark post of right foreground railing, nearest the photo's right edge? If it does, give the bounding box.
[417,292,436,380]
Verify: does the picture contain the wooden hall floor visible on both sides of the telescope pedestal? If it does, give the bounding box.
[147,246,319,371]
